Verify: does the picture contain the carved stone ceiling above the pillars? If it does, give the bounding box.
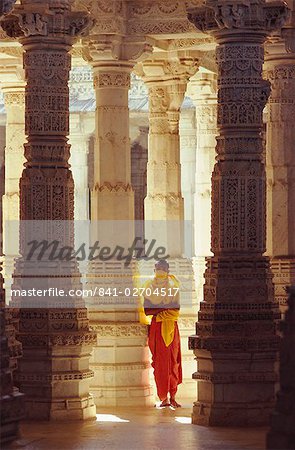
[0,0,294,71]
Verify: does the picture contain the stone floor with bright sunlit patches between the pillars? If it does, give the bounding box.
[6,407,266,450]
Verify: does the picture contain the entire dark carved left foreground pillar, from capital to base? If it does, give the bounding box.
[2,0,96,420]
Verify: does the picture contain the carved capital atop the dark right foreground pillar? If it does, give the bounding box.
[188,0,290,39]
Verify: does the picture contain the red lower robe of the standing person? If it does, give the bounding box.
[148,316,182,401]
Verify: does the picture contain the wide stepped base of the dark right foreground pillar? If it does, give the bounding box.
[189,257,280,426]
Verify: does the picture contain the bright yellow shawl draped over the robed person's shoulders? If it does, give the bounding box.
[139,274,180,347]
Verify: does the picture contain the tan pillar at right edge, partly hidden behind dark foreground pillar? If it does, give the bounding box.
[265,32,295,313]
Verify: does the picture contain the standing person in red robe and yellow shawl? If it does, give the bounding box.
[144,260,182,408]
